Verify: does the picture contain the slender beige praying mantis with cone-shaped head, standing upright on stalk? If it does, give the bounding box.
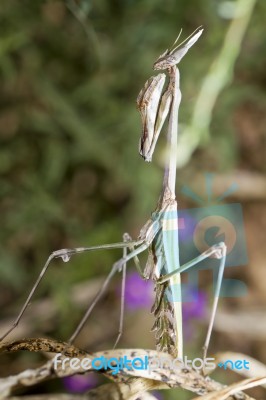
[0,27,226,359]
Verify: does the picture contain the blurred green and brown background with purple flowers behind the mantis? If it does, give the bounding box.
[0,0,266,400]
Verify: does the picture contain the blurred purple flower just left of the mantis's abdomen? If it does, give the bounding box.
[118,271,154,310]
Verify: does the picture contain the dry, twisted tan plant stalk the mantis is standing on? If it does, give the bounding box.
[0,338,266,400]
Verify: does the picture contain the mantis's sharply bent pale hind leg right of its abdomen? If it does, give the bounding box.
[157,242,226,360]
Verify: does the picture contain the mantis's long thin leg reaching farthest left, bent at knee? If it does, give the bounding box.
[0,240,143,342]
